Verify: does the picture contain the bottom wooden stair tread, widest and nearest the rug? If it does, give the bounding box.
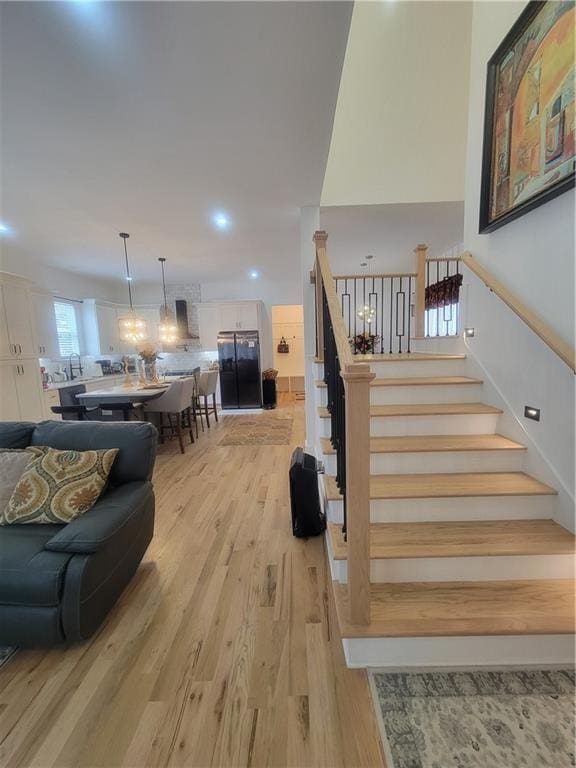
[334,579,575,638]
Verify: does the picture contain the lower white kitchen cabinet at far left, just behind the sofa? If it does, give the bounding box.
[0,360,45,421]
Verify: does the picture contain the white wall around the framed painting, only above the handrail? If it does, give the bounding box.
[464,2,574,343]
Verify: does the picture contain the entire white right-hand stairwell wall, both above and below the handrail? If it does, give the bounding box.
[463,2,575,529]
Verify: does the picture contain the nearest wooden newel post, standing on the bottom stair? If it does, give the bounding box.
[342,363,374,624]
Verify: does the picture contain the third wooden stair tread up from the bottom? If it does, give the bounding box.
[324,472,556,501]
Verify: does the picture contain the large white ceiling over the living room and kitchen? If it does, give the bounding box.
[0,0,351,282]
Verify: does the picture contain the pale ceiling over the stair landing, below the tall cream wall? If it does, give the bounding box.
[320,202,464,274]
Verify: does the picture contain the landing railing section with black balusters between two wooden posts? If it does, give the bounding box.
[334,272,416,354]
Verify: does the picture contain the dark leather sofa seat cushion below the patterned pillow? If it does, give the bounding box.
[0,525,72,608]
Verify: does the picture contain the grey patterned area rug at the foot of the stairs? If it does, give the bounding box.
[370,669,576,768]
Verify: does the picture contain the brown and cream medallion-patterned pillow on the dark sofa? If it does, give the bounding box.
[0,447,118,525]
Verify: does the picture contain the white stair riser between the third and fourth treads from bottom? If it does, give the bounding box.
[322,451,525,475]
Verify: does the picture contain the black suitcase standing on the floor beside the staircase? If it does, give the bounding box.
[289,448,326,539]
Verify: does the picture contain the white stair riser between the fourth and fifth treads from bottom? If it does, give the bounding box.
[368,413,499,437]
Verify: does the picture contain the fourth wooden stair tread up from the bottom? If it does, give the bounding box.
[320,435,526,454]
